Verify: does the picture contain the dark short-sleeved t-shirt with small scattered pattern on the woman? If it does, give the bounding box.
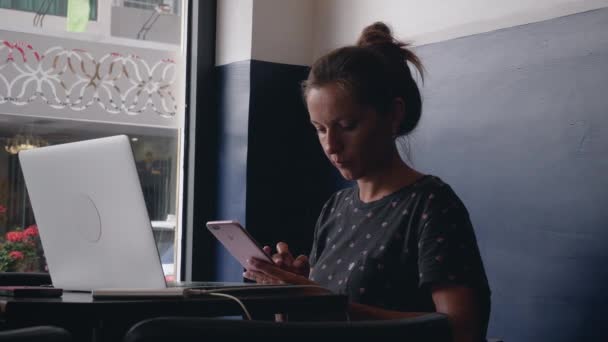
[310,175,490,312]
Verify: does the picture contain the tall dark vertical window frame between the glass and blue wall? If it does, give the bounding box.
[178,0,219,281]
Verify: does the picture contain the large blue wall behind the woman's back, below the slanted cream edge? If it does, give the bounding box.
[411,9,608,342]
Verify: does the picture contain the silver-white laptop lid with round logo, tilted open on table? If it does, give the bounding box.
[19,135,166,291]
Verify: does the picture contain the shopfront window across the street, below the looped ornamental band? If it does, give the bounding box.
[0,123,179,275]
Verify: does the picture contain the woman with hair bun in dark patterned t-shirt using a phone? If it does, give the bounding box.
[244,23,490,341]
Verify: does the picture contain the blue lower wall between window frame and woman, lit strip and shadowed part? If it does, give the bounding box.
[214,60,339,281]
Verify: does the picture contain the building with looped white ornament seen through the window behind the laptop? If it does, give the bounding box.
[0,0,187,278]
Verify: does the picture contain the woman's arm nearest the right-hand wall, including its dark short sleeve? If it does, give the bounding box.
[417,186,489,342]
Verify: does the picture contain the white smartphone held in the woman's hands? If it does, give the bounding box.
[207,220,272,268]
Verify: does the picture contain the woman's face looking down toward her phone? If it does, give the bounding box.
[306,84,395,180]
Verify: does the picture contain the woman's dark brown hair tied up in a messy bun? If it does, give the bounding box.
[302,22,424,135]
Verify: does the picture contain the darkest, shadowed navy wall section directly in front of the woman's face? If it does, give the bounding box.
[247,61,339,254]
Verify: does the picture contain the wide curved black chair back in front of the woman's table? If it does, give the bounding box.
[124,313,451,342]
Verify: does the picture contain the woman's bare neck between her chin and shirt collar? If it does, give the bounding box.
[357,154,423,203]
